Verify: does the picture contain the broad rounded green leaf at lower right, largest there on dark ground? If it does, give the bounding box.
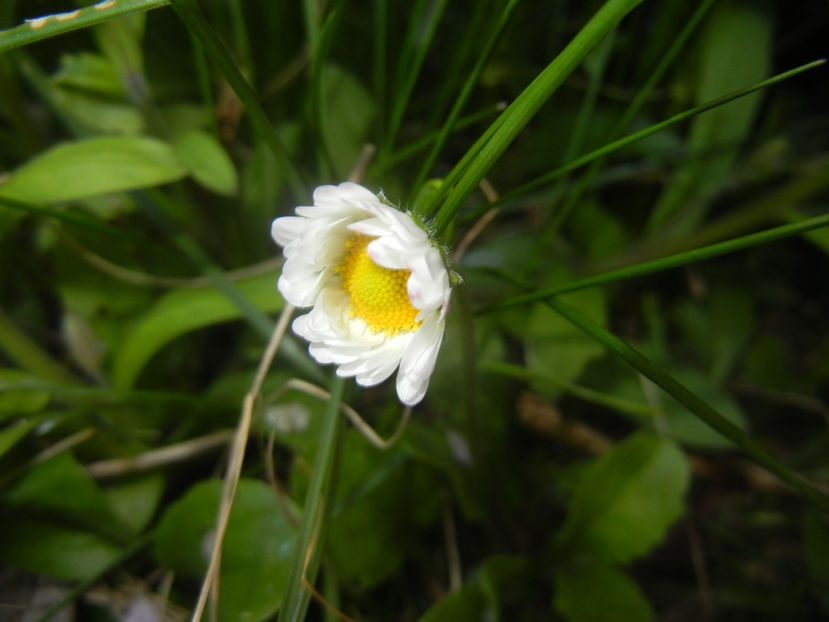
[558,432,690,563]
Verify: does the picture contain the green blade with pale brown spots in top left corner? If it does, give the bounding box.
[0,0,170,54]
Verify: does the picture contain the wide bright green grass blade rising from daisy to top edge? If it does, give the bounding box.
[434,0,642,232]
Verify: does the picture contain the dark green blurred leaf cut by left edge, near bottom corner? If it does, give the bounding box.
[0,520,121,580]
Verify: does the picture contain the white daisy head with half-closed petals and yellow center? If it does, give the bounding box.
[271,182,450,405]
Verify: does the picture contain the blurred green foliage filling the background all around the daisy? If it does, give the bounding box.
[0,0,829,622]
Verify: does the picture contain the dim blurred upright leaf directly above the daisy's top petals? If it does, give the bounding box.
[321,65,374,179]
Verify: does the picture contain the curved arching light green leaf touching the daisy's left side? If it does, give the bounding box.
[113,274,285,389]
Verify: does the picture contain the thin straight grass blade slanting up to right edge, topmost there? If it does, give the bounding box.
[487,59,826,208]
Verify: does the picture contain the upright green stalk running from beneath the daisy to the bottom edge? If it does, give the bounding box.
[277,376,345,622]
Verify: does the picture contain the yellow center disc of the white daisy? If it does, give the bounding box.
[337,234,420,335]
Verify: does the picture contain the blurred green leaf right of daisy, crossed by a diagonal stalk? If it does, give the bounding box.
[524,288,606,399]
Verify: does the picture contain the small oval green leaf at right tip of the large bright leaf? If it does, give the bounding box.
[173,131,238,195]
